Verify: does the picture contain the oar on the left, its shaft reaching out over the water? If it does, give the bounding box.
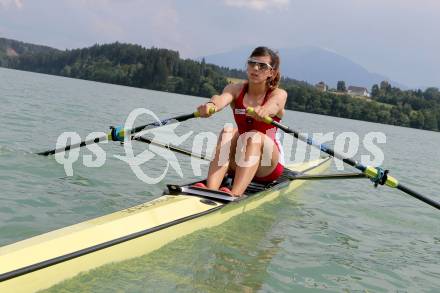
[37,108,215,156]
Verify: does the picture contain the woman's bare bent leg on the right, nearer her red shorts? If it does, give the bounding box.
[231,131,279,196]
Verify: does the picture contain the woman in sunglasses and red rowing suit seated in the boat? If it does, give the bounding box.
[197,47,287,196]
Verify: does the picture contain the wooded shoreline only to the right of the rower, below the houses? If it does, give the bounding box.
[286,81,440,131]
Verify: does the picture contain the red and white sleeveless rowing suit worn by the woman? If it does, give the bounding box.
[233,83,284,182]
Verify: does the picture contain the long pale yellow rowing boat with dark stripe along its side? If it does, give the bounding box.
[0,157,330,292]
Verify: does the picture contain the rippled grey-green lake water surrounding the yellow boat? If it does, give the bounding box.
[0,68,440,292]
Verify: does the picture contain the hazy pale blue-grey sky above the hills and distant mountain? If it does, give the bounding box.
[0,0,440,87]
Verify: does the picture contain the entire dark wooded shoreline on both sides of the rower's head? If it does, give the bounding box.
[0,38,440,131]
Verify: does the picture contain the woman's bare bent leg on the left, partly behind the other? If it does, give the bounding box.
[207,127,238,189]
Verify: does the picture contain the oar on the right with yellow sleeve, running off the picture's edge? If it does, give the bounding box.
[246,107,440,210]
